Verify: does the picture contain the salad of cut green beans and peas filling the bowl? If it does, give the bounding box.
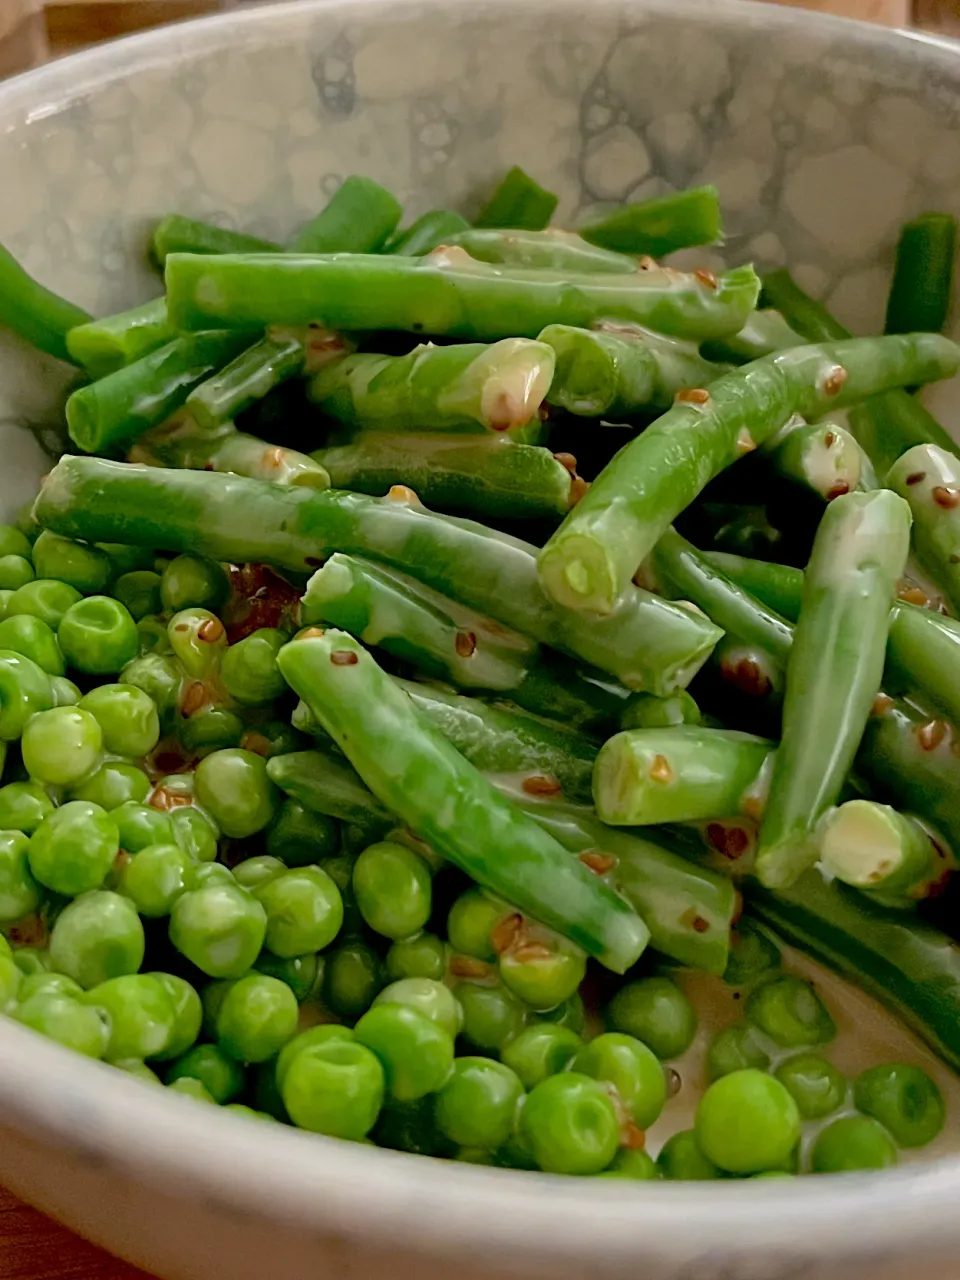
[0,169,960,1180]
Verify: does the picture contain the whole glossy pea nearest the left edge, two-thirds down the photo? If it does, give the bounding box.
[29,800,120,897]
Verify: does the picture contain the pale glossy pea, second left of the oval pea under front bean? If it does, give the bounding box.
[170,880,266,978]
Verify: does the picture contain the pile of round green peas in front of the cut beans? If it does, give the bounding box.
[0,520,943,1180]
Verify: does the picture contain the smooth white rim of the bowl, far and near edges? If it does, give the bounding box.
[0,0,960,1271]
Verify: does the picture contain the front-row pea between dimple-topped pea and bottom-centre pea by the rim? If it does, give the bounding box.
[434,1057,524,1151]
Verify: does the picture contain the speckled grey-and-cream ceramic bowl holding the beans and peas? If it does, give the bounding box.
[0,0,960,1280]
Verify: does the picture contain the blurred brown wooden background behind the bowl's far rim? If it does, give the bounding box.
[0,0,960,76]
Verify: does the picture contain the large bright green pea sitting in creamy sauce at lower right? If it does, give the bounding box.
[520,1071,620,1176]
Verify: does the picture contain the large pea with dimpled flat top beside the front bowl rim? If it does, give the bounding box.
[279,1034,384,1142]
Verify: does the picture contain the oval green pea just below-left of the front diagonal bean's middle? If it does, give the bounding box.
[353,840,433,940]
